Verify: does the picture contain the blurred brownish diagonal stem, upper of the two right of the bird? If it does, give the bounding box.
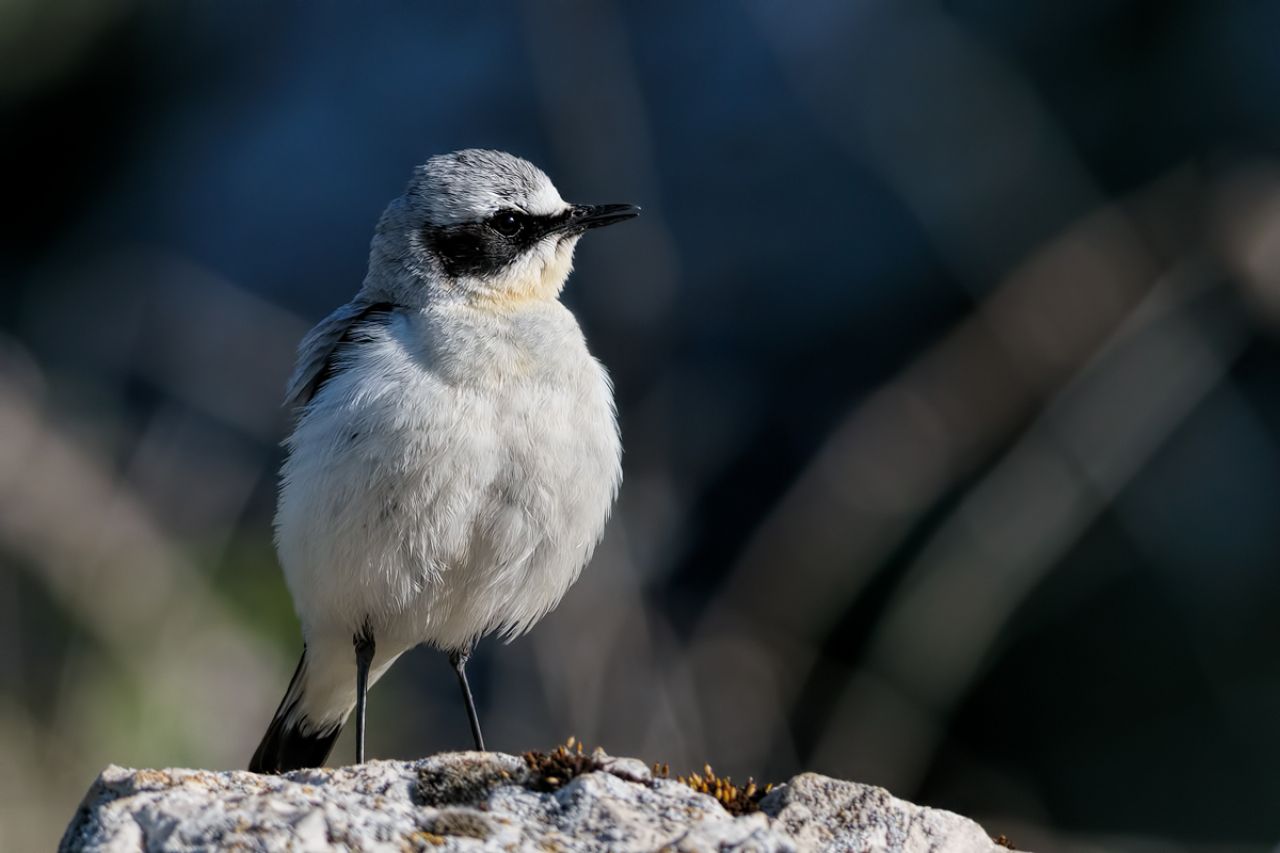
[704,184,1158,679]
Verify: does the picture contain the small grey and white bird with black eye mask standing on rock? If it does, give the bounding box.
[250,150,639,772]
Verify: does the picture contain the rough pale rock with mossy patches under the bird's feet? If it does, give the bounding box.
[60,753,1002,853]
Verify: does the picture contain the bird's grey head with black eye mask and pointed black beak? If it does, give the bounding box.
[366,149,640,309]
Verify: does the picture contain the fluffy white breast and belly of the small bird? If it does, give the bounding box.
[276,302,621,648]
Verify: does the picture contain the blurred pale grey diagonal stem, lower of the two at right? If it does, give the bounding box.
[817,253,1248,790]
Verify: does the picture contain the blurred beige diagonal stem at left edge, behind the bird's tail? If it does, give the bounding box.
[0,335,284,835]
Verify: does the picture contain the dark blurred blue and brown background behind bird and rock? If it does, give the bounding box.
[0,0,1280,850]
